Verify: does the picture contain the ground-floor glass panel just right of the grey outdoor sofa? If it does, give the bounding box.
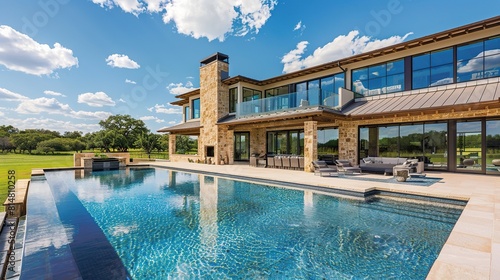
[422,123,448,169]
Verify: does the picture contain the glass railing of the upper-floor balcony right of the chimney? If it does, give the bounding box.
[236,89,339,117]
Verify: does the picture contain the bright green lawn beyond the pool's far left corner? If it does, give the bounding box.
[0,153,73,211]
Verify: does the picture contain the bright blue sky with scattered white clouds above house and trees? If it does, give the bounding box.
[0,0,500,133]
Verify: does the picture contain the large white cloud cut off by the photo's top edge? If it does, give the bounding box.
[92,0,277,41]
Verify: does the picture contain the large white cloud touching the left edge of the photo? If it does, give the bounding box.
[0,25,78,76]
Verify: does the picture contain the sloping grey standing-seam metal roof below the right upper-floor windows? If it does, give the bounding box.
[342,78,500,117]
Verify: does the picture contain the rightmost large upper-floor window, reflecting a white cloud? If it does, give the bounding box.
[457,37,500,82]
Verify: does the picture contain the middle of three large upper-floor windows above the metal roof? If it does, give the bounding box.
[412,48,453,89]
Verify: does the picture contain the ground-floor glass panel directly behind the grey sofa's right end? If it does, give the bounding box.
[399,124,424,158]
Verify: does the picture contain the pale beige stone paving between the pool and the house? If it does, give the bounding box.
[142,161,500,280]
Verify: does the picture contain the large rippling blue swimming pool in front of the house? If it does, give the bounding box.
[21,168,463,279]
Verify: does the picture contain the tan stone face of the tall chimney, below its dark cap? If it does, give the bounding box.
[198,61,232,164]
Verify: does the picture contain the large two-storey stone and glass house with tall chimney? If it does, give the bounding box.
[159,16,500,174]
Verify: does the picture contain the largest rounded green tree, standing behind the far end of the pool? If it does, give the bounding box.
[99,115,148,152]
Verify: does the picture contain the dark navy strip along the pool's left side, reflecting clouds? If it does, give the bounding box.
[21,175,131,279]
